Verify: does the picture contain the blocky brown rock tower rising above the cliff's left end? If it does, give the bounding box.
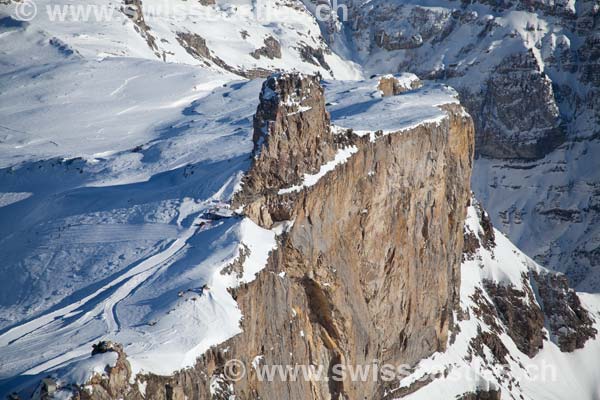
[233,74,337,226]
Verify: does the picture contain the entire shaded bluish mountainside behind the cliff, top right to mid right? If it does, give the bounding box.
[330,0,600,290]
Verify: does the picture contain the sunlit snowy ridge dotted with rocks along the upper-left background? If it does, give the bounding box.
[0,0,360,79]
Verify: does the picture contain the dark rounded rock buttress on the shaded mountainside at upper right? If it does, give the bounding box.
[472,50,565,159]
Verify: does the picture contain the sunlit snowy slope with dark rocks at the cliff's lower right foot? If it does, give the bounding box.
[380,198,598,399]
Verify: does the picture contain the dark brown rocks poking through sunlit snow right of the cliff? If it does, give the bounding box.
[464,201,597,363]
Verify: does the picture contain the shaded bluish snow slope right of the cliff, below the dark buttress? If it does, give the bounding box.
[472,141,600,293]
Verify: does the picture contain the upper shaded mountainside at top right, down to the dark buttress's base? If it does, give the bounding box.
[333,0,600,160]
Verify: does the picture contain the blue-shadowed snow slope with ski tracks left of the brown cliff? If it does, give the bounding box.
[0,71,275,384]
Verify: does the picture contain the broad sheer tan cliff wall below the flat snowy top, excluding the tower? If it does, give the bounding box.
[225,76,473,398]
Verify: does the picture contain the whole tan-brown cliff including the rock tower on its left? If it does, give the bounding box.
[64,75,473,399]
